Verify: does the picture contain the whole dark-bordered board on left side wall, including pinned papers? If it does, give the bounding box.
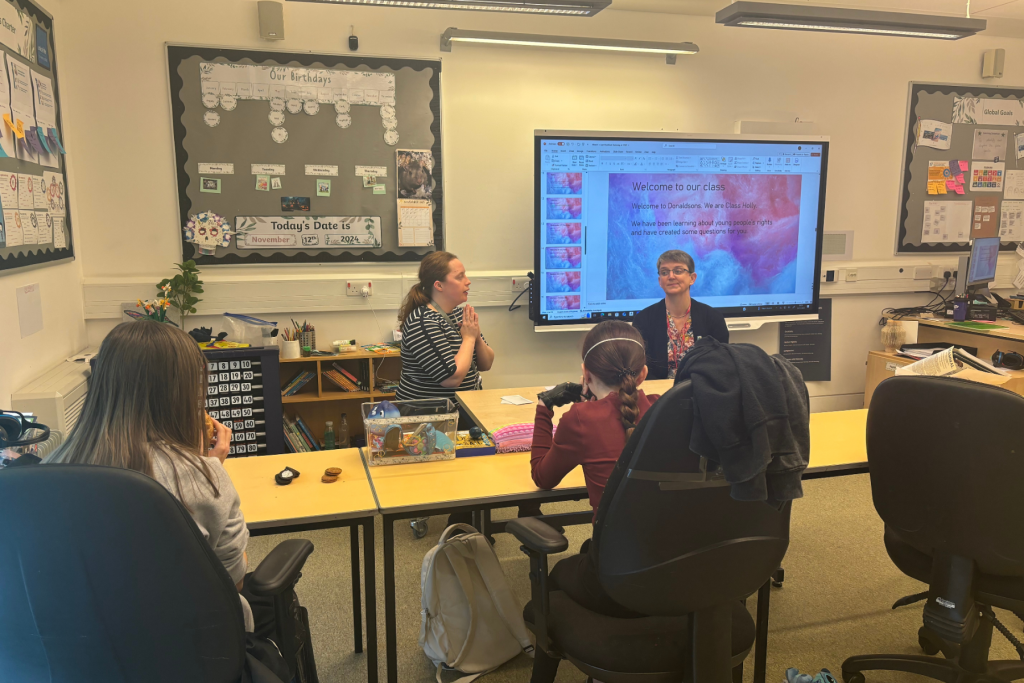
[0,0,75,271]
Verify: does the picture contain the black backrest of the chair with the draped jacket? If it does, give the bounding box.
[591,381,790,615]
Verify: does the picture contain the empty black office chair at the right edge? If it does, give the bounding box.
[843,377,1024,683]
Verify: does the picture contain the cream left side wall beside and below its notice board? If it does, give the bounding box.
[0,0,85,408]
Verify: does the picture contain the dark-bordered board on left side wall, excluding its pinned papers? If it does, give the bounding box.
[0,0,75,272]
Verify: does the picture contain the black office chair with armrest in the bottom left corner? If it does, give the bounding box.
[0,465,317,683]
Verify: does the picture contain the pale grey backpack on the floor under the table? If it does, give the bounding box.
[420,524,534,683]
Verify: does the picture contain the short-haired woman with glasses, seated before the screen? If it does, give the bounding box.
[633,249,729,380]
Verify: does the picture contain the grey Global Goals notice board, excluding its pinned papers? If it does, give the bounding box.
[896,83,1024,254]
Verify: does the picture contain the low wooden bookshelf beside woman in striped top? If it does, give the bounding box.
[281,349,401,450]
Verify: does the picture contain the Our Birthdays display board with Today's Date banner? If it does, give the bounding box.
[165,45,444,265]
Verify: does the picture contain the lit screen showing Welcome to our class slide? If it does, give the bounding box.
[538,138,822,322]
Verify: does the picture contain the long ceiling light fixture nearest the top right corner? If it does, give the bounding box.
[715,2,986,40]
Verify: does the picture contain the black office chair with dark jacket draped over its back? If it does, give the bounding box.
[506,381,790,683]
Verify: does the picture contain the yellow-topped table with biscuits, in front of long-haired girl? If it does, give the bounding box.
[224,449,378,683]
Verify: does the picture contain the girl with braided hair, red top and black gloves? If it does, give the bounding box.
[530,321,657,515]
